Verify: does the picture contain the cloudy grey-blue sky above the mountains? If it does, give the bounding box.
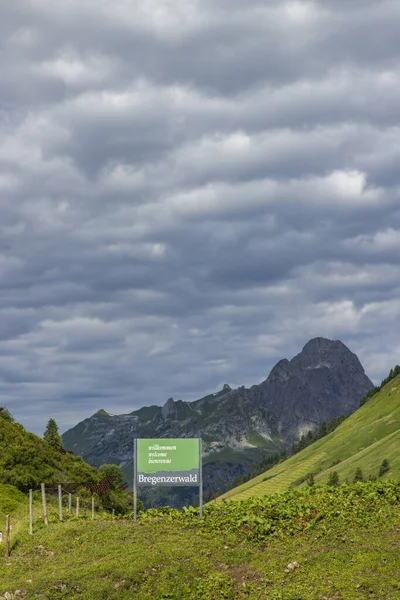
[0,0,400,434]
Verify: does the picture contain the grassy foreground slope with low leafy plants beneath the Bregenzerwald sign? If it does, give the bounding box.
[0,482,400,600]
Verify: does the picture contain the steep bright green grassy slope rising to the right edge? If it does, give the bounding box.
[217,376,400,500]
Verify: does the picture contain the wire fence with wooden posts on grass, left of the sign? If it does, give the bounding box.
[0,482,128,558]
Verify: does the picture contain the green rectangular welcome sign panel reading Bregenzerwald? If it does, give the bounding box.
[136,438,200,486]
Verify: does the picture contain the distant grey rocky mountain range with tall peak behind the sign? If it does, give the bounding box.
[63,338,373,502]
